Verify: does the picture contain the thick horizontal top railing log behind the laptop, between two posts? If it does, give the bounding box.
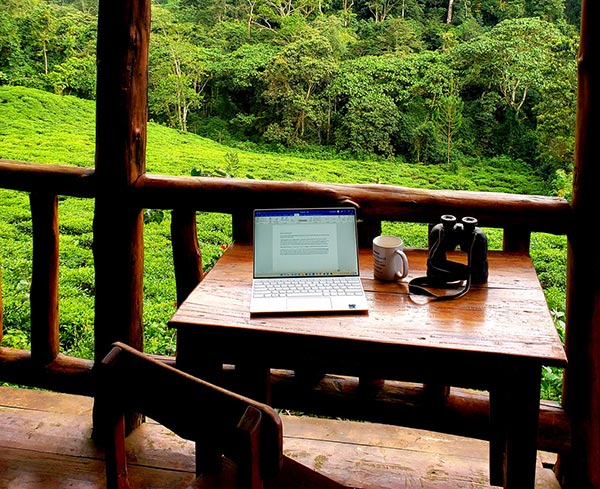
[135,174,571,234]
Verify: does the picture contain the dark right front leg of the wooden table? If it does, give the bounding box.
[490,366,541,489]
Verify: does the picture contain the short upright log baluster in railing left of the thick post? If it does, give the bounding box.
[29,193,59,365]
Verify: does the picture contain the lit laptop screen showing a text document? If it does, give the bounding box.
[254,207,359,278]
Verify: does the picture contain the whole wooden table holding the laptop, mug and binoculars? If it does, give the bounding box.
[170,244,566,488]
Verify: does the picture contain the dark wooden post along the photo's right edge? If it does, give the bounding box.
[559,0,600,489]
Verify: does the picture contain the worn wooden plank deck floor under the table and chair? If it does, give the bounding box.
[0,387,560,489]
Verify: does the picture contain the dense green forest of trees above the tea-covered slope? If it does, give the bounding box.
[0,0,580,191]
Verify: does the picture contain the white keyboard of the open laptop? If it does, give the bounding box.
[253,277,362,298]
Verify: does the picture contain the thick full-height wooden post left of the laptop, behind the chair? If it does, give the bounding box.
[94,0,150,361]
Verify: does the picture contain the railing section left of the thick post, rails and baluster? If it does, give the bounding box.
[0,160,94,395]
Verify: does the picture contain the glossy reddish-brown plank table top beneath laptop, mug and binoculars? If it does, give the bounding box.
[169,243,566,367]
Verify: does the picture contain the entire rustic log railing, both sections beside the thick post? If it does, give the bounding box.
[0,160,572,452]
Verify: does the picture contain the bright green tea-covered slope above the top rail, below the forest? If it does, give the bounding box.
[0,86,545,194]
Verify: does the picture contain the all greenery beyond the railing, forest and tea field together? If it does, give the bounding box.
[0,0,581,404]
